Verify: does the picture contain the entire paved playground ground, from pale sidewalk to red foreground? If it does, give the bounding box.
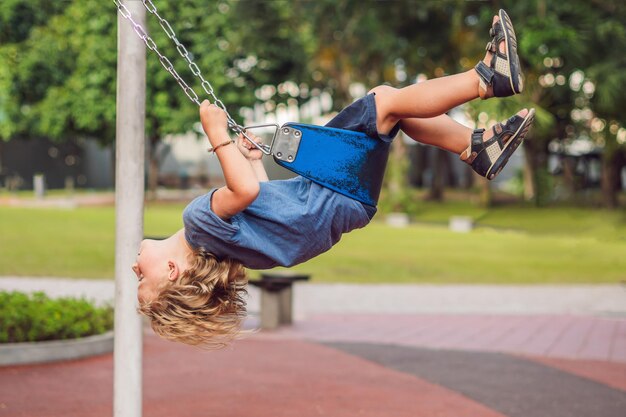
[0,279,626,417]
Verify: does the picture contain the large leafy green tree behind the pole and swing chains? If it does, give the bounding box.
[0,0,305,190]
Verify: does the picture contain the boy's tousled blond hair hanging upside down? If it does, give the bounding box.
[139,249,247,349]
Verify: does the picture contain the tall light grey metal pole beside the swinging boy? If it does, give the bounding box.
[113,1,146,417]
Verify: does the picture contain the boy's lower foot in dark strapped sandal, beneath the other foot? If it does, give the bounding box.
[460,109,535,180]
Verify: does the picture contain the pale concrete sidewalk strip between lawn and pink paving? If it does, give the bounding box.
[0,277,626,319]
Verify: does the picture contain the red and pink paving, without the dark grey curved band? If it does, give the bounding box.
[0,315,626,417]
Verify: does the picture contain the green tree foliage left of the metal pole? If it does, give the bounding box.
[0,1,116,142]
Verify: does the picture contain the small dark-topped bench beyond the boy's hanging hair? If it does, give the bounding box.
[248,272,310,330]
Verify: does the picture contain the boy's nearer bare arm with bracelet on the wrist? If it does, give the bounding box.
[200,100,259,220]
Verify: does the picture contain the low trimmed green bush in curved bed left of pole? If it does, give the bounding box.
[0,291,113,343]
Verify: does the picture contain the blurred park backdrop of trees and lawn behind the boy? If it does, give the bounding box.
[0,0,626,283]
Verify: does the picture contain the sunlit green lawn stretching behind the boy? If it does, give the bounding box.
[0,203,626,284]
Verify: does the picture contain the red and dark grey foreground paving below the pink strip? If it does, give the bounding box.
[0,333,626,417]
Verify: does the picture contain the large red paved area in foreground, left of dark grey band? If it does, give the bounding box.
[0,336,502,417]
